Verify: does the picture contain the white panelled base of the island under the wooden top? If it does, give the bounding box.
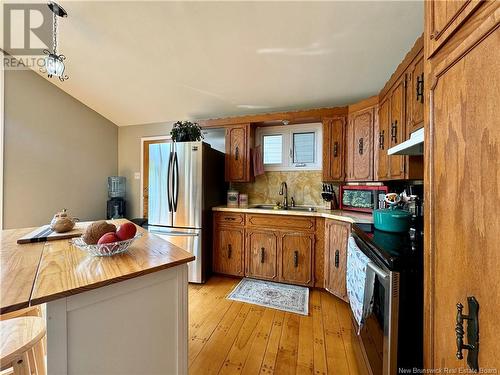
[47,264,188,375]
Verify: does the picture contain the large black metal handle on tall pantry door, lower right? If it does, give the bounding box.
[455,297,479,372]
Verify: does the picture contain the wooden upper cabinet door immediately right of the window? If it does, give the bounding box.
[323,117,346,182]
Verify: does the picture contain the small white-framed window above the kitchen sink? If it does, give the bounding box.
[256,123,322,171]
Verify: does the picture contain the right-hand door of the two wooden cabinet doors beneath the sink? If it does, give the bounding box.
[280,233,314,285]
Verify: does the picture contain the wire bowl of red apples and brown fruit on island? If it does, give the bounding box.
[71,220,142,257]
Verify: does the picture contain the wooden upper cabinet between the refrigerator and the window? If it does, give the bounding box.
[225,124,252,182]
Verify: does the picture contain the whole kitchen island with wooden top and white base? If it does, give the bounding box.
[0,219,194,374]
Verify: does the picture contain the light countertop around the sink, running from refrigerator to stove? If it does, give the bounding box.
[212,205,373,224]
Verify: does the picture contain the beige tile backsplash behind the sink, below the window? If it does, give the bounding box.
[232,171,335,206]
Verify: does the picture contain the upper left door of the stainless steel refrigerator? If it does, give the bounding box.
[147,142,173,226]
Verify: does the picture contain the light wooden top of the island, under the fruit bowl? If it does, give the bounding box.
[0,219,194,314]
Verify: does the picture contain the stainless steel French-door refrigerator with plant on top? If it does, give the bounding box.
[148,142,226,283]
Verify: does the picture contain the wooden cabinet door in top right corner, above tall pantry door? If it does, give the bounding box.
[425,0,481,57]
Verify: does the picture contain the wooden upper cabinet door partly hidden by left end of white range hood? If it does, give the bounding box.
[389,76,406,180]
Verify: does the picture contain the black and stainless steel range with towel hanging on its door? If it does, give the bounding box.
[352,224,423,375]
